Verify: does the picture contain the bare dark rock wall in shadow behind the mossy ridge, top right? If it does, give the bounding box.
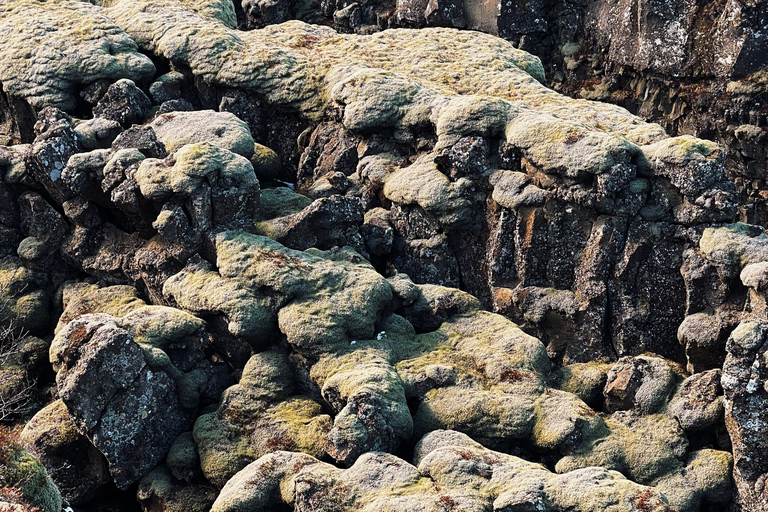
[260,0,768,230]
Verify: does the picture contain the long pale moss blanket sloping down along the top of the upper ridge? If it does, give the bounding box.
[100,0,696,152]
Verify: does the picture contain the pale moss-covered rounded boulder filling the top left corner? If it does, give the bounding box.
[0,0,155,110]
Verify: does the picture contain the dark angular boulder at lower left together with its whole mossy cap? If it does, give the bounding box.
[51,306,213,488]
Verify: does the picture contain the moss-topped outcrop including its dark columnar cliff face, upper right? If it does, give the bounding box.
[75,3,748,368]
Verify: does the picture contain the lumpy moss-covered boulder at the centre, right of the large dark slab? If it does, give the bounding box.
[164,231,392,355]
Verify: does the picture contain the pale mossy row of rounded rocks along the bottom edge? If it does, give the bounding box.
[212,431,680,512]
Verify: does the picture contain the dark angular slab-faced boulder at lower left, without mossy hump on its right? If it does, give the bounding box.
[51,314,206,488]
